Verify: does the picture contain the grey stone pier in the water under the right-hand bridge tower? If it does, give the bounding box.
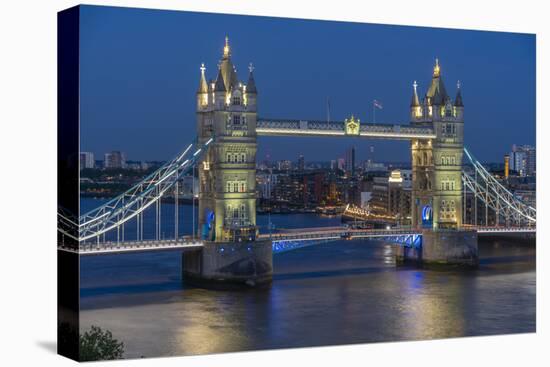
[396,230,478,268]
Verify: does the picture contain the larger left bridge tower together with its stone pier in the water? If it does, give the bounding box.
[183,37,272,285]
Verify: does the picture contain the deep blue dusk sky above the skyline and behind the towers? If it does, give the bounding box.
[80,6,535,161]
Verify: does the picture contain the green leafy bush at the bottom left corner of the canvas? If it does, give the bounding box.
[79,326,124,361]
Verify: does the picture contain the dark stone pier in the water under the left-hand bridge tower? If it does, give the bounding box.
[182,239,273,288]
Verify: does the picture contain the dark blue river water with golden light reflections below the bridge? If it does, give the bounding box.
[80,199,536,358]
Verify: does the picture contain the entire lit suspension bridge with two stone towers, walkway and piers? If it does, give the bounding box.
[58,38,536,290]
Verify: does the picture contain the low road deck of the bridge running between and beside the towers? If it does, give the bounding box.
[58,226,536,255]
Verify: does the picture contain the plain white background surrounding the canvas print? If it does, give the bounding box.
[0,0,550,367]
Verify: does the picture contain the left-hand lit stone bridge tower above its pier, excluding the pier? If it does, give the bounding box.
[197,38,257,242]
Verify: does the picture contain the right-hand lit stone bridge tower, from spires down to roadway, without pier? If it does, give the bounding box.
[410,59,464,229]
